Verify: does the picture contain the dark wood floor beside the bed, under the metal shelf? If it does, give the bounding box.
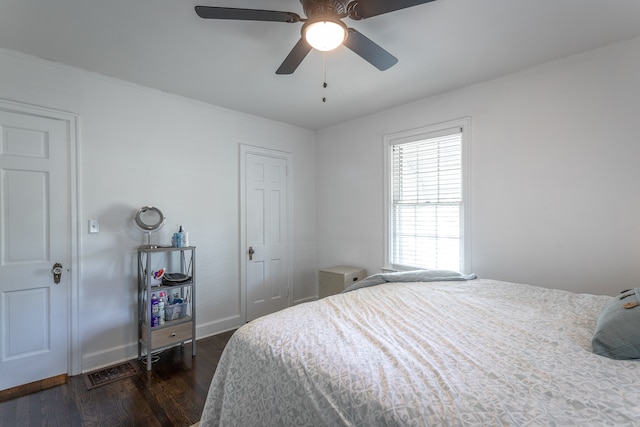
[0,331,233,427]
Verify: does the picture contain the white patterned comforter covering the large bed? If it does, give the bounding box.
[201,280,640,427]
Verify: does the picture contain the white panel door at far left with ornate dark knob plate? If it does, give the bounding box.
[0,110,70,390]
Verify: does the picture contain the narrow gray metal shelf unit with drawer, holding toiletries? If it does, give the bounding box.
[138,246,196,370]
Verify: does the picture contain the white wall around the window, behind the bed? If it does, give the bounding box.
[317,39,640,294]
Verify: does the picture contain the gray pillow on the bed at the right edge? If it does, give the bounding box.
[591,288,640,359]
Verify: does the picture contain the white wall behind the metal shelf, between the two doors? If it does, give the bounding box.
[0,50,316,371]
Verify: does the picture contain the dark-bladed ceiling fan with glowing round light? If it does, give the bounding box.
[195,0,434,74]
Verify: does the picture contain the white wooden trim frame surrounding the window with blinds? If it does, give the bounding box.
[382,117,471,273]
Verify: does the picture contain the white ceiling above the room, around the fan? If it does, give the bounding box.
[0,0,640,130]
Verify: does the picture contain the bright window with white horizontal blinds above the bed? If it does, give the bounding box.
[385,119,469,271]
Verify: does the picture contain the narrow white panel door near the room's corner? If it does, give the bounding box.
[245,153,291,321]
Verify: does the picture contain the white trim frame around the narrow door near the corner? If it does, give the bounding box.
[239,144,293,323]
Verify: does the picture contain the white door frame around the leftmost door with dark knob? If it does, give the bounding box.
[0,98,82,375]
